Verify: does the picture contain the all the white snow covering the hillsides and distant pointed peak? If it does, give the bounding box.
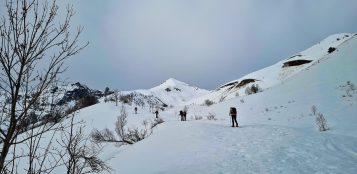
[5,33,357,174]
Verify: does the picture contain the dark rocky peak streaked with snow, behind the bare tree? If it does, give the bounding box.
[57,82,103,105]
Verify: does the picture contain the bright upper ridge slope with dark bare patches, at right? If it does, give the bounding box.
[188,33,355,104]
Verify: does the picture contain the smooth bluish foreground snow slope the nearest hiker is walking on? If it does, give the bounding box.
[100,33,357,174]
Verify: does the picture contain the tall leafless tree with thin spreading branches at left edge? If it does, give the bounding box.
[0,0,87,173]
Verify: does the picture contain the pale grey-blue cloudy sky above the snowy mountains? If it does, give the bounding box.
[60,0,357,90]
